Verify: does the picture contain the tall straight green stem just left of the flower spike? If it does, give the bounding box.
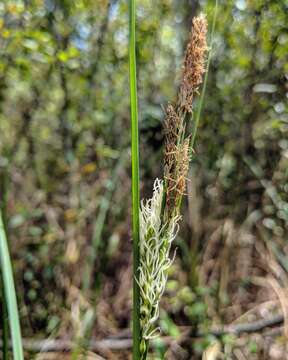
[129,0,141,360]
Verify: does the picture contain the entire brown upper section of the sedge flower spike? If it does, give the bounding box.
[164,15,207,221]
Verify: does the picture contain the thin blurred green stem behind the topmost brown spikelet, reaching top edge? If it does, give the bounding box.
[190,0,218,150]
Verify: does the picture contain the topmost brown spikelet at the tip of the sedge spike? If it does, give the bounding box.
[179,14,207,112]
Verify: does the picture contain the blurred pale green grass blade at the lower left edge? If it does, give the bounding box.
[0,210,24,360]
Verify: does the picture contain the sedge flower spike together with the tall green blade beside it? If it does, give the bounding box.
[129,0,207,360]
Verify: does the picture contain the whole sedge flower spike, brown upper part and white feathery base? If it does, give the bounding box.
[135,14,207,360]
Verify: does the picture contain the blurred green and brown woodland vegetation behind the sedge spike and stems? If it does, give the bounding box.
[0,0,288,359]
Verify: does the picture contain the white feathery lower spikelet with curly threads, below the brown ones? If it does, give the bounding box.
[139,179,179,340]
